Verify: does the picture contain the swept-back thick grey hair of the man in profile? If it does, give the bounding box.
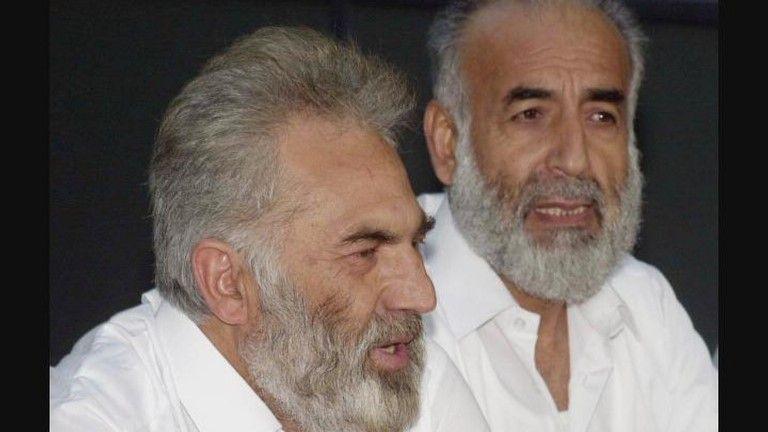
[149,27,414,323]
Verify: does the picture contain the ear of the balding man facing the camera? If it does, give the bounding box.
[424,99,458,186]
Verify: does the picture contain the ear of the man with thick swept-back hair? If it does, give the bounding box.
[192,239,258,325]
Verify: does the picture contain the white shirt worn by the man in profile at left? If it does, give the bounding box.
[50,290,488,432]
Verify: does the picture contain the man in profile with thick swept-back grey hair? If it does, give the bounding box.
[50,28,487,432]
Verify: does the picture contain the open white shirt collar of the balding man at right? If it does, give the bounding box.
[422,197,638,339]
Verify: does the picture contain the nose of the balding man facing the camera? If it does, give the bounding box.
[547,113,589,177]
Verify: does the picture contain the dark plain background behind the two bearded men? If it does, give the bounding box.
[49,0,719,365]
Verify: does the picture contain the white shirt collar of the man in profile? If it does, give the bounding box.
[143,291,282,432]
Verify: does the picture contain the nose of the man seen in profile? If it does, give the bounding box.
[381,249,437,314]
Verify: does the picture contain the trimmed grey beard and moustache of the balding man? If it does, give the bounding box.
[447,134,642,304]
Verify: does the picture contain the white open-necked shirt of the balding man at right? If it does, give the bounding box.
[419,194,718,432]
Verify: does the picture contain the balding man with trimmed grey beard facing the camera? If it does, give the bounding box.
[420,0,718,432]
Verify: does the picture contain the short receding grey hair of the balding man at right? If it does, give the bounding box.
[427,0,646,132]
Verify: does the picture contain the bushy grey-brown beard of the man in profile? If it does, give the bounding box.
[239,270,423,432]
